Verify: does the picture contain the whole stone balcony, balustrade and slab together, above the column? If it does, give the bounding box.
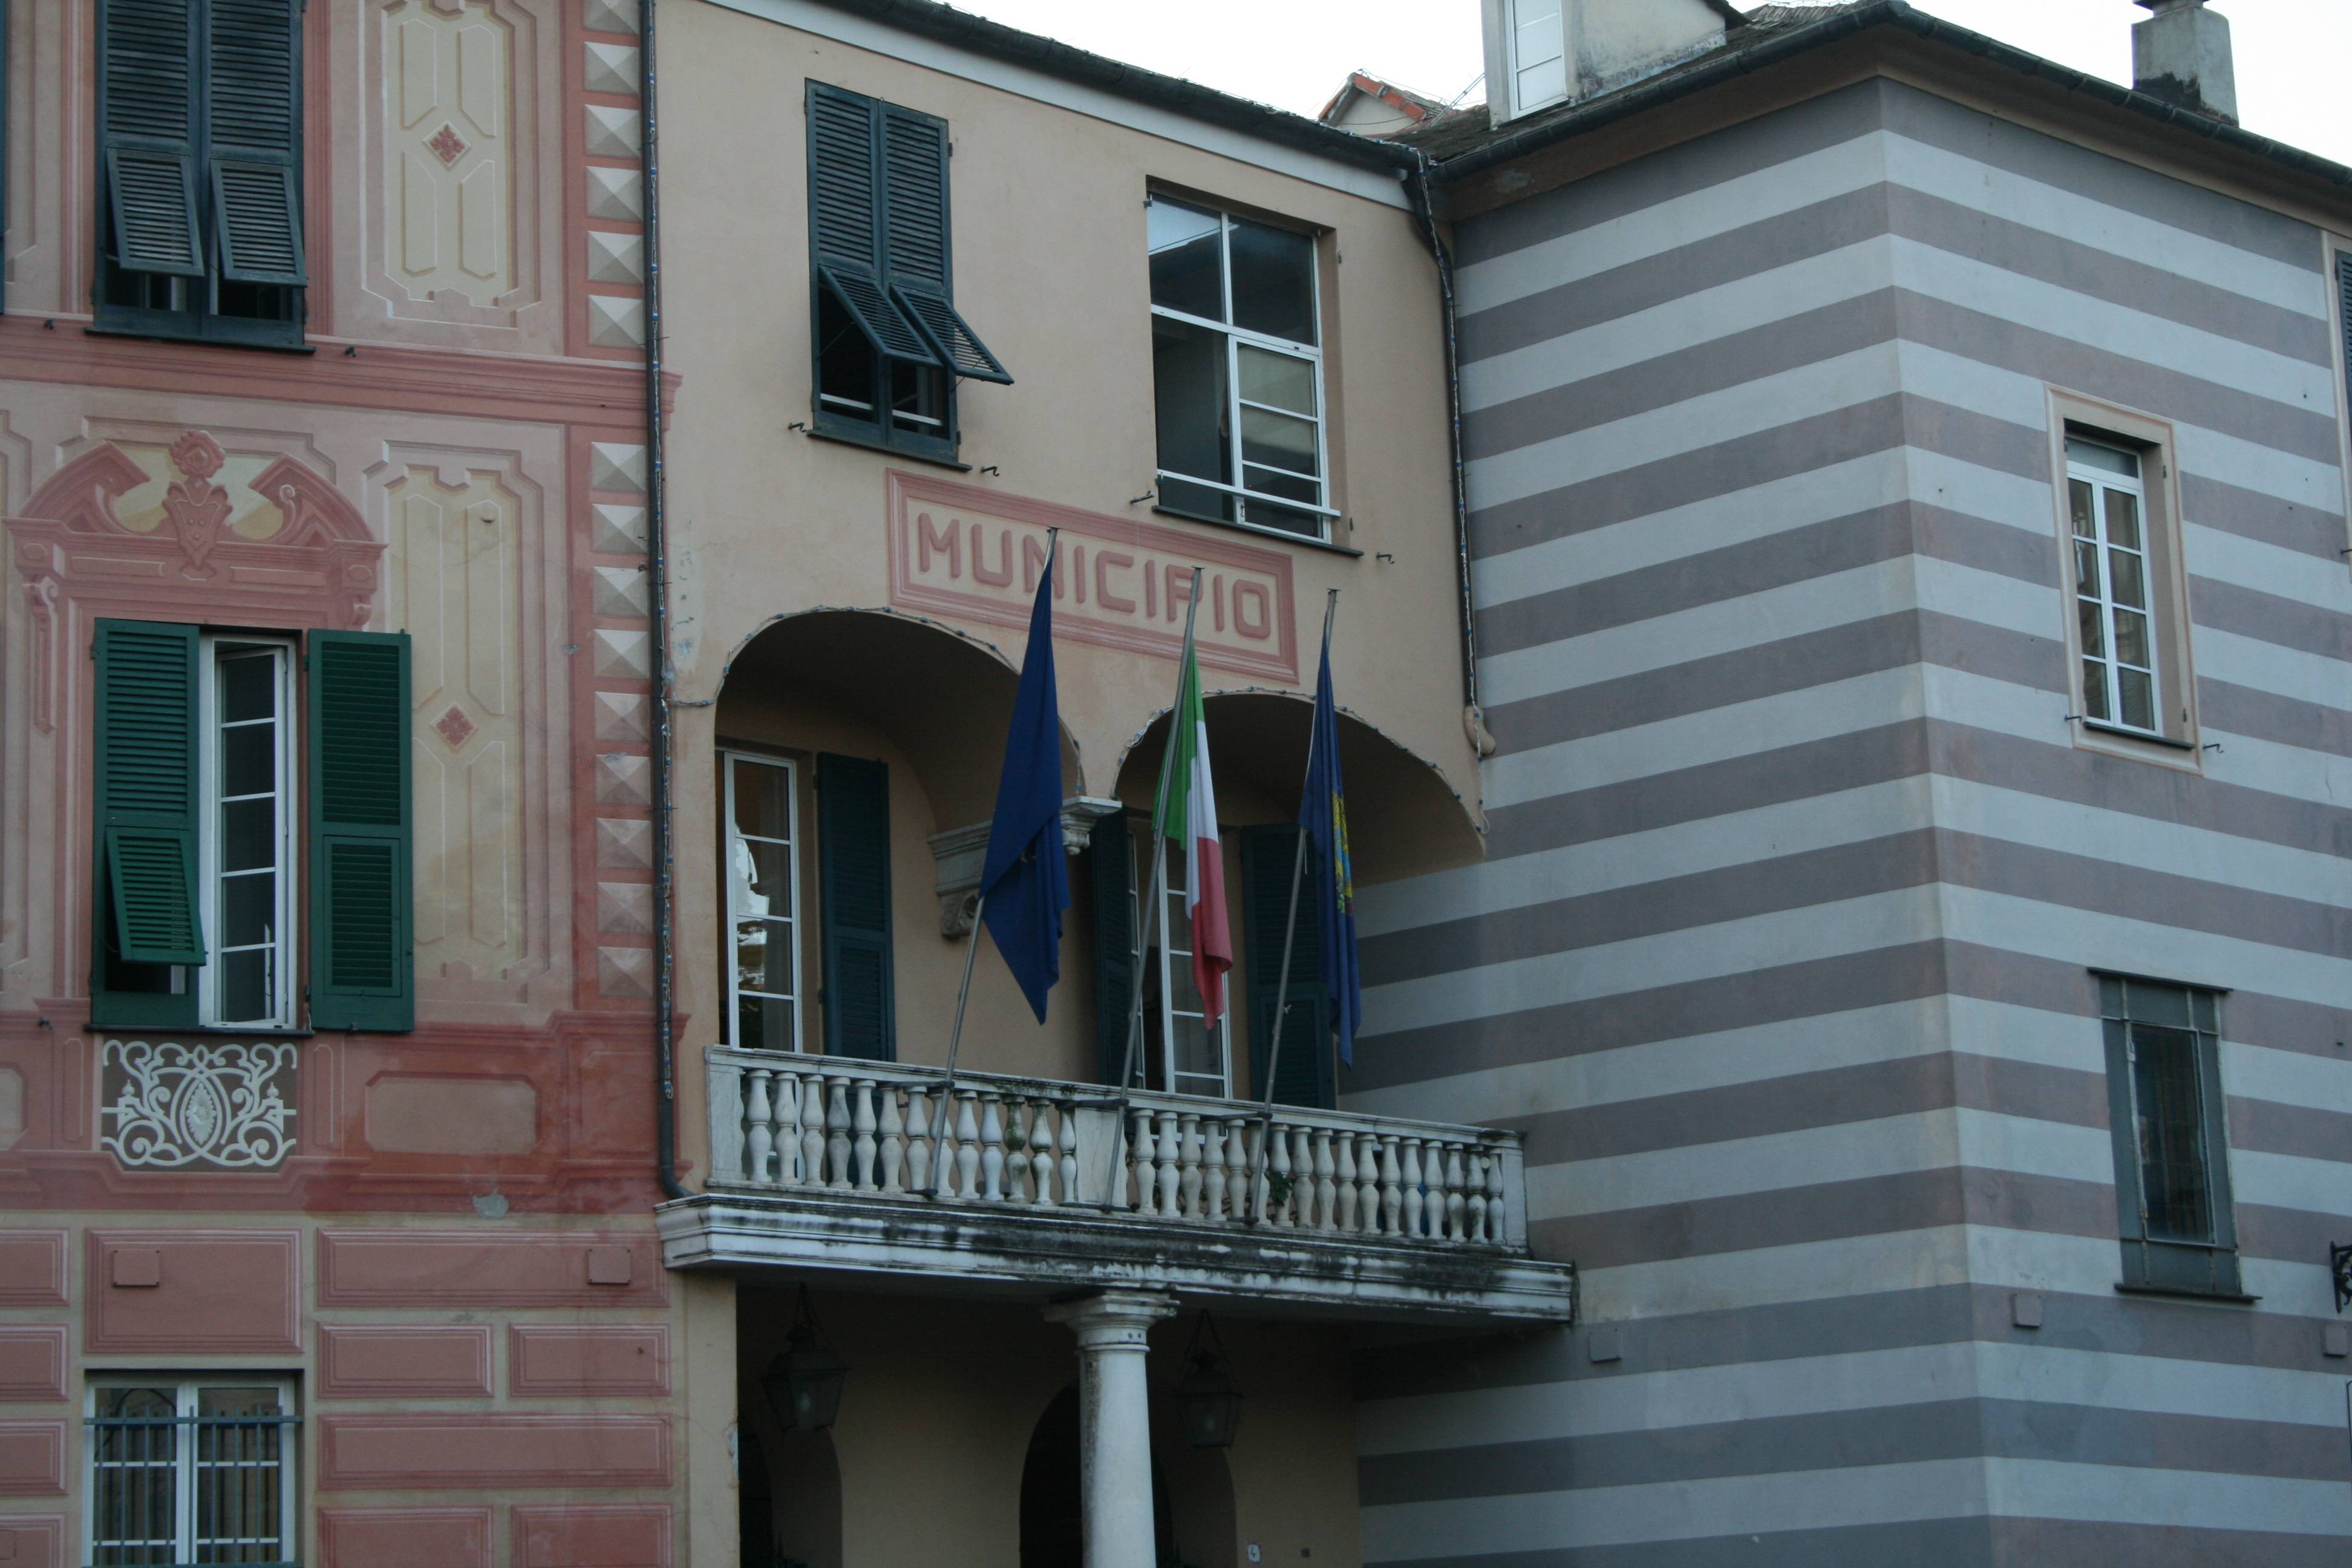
[659,1048,1573,1321]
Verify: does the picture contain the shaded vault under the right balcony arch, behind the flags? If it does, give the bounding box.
[1117,687,1484,886]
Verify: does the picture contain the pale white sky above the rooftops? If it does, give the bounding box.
[955,0,2352,165]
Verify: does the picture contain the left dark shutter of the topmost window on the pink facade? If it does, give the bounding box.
[99,0,204,278]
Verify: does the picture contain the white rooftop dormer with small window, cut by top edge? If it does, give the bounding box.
[1481,0,1740,125]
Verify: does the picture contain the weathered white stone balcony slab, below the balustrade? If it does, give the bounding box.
[656,1192,1576,1324]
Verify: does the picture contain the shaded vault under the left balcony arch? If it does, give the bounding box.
[710,607,1084,828]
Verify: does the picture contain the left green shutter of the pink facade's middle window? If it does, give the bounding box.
[92,621,204,969]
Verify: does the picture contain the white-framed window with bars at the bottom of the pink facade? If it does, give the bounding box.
[82,1373,301,1568]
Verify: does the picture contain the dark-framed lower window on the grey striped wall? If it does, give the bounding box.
[2098,976,2241,1295]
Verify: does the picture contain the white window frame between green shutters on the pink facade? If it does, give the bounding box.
[195,632,301,1030]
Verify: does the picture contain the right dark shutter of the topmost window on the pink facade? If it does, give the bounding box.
[204,0,308,287]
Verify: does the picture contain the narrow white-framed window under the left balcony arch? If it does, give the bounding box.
[720,753,802,1051]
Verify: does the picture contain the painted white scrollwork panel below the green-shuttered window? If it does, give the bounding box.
[99,1039,299,1171]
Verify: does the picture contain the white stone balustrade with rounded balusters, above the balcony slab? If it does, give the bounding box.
[708,1048,1526,1253]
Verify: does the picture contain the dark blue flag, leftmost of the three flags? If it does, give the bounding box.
[981,550,1070,1022]
